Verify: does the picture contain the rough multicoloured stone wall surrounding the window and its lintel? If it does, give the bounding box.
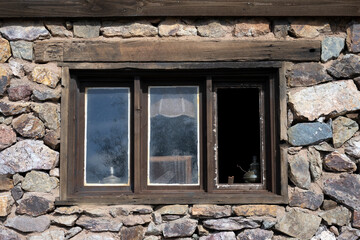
[0,18,360,240]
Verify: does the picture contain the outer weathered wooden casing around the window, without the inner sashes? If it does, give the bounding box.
[55,61,288,205]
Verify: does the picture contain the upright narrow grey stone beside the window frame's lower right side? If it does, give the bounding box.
[288,149,311,189]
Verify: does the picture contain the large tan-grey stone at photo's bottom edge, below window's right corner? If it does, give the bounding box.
[275,210,321,239]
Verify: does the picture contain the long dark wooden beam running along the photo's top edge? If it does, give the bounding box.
[0,0,360,18]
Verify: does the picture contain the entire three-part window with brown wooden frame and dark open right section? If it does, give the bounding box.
[60,67,287,204]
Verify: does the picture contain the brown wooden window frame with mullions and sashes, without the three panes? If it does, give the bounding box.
[56,62,288,205]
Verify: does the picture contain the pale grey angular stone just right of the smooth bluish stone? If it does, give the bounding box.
[332,116,359,148]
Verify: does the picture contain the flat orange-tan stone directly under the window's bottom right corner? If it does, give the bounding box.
[232,205,282,217]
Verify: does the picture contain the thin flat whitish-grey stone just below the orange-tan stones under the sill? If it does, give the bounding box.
[203,217,261,231]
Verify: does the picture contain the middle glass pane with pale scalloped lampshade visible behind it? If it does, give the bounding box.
[148,86,199,185]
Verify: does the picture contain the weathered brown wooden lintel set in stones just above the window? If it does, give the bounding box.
[34,39,321,62]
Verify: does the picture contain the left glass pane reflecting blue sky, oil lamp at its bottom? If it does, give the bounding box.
[85,88,130,185]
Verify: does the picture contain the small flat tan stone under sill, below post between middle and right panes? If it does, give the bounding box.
[191,204,231,218]
